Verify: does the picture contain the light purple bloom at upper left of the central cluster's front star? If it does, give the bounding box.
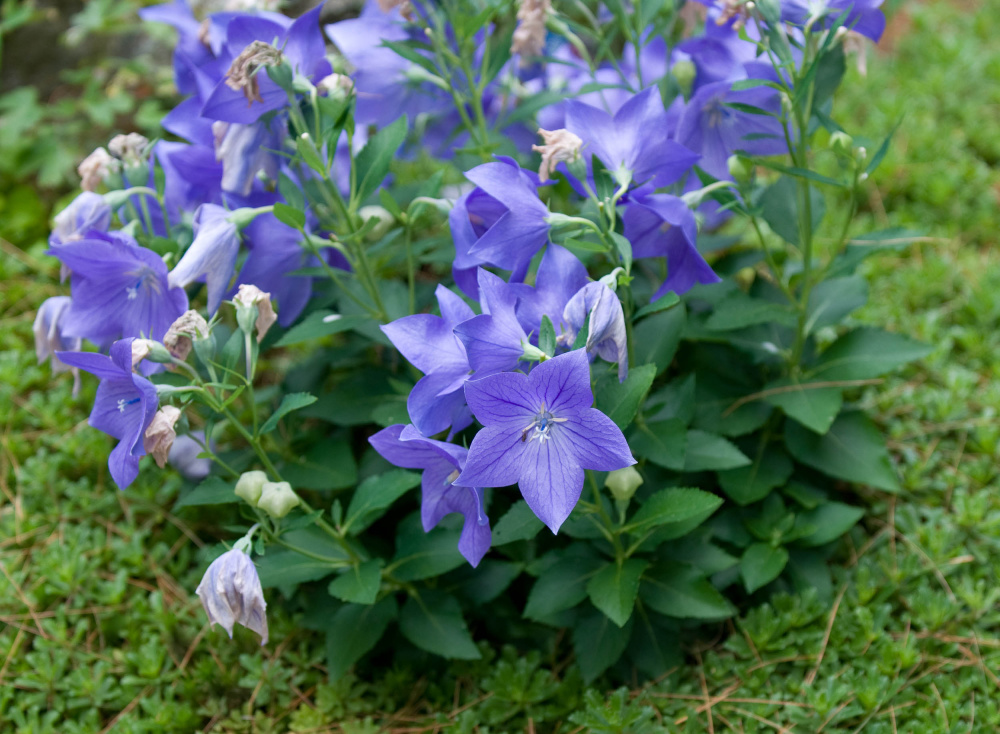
[382,284,476,436]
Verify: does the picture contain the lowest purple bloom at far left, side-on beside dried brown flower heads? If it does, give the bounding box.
[56,338,158,489]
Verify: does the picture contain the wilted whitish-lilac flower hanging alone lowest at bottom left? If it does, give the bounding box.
[195,548,267,645]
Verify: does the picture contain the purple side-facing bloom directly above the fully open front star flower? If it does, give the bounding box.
[455,268,529,376]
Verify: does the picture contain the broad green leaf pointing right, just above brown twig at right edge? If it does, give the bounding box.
[808,327,931,380]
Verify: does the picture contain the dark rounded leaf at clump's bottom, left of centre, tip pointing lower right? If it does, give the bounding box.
[399,590,482,660]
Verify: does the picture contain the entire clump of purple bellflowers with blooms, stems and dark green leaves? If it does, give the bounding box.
[23,0,928,684]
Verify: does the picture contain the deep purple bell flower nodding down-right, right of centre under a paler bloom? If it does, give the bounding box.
[622,194,721,301]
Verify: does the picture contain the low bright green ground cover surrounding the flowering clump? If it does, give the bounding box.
[0,2,1000,734]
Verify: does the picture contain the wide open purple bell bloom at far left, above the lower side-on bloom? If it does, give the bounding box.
[49,232,187,344]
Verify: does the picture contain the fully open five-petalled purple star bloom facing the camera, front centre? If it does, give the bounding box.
[455,349,635,533]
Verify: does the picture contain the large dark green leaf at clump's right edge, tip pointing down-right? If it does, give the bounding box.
[785,411,900,492]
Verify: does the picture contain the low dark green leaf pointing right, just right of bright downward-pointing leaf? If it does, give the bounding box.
[639,564,736,621]
